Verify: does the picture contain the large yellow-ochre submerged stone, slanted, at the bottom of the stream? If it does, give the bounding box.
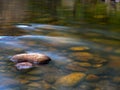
[56,73,85,87]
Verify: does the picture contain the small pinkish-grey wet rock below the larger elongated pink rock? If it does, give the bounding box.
[15,62,33,70]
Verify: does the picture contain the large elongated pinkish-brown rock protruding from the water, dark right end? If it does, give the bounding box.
[10,53,51,64]
